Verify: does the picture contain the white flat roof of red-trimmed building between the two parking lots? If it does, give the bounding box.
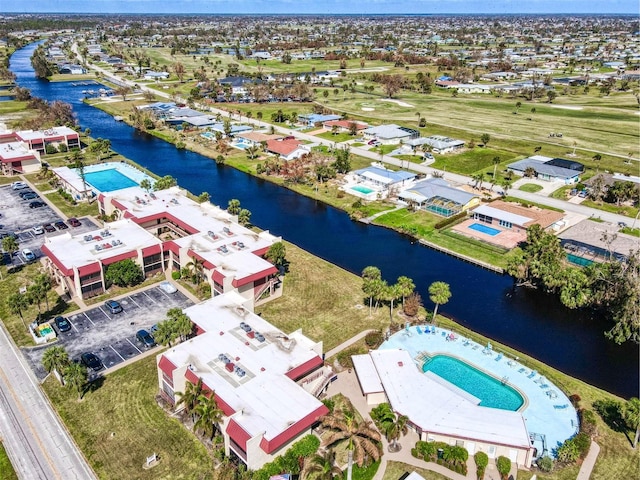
[45,220,162,268]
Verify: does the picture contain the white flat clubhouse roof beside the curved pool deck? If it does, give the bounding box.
[369,349,531,448]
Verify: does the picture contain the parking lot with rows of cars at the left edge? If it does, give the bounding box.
[0,185,99,265]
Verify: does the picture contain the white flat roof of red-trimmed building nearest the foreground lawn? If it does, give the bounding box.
[164,292,321,440]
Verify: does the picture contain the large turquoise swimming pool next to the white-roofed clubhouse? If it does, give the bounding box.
[422,355,524,412]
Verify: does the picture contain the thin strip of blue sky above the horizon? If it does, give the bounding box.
[0,0,640,15]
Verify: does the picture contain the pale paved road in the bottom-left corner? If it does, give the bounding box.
[0,325,97,480]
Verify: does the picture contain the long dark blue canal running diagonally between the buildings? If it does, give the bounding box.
[10,44,639,397]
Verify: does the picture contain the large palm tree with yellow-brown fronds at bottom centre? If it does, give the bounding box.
[320,410,382,480]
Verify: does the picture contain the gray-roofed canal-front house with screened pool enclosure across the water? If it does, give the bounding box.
[398,177,480,217]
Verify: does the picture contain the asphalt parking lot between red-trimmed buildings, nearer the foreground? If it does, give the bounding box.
[22,286,193,379]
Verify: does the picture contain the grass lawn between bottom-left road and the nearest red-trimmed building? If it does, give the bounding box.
[43,356,213,480]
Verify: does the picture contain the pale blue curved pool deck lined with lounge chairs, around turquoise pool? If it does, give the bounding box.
[380,326,578,455]
